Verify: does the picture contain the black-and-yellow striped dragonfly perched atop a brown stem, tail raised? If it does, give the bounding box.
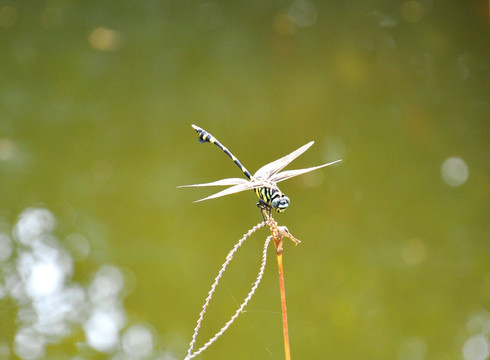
[178,125,342,220]
